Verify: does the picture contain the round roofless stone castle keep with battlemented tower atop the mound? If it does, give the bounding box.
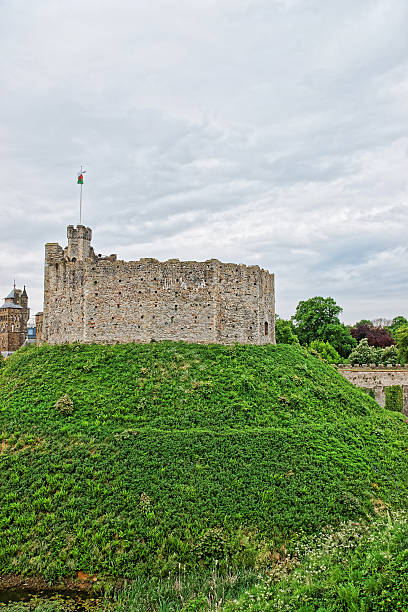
[37,225,275,344]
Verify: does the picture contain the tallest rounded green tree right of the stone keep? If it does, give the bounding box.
[294,296,357,357]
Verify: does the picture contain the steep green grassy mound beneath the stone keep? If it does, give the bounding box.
[0,342,408,580]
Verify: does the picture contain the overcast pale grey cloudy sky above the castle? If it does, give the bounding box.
[0,0,408,323]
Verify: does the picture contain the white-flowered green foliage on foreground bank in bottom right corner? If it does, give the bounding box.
[223,512,408,612]
